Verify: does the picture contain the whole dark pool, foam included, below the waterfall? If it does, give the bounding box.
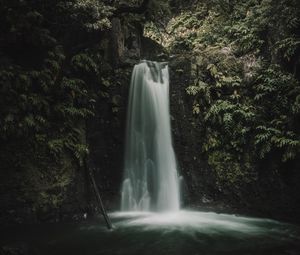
[0,211,300,255]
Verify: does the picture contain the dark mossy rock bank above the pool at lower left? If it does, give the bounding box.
[0,153,87,226]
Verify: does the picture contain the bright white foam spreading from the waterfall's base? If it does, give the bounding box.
[110,210,298,239]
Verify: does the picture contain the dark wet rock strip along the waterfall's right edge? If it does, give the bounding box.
[169,56,214,205]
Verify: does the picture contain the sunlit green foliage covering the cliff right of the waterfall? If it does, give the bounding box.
[166,0,300,188]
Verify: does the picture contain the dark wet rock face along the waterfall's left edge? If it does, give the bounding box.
[86,23,150,210]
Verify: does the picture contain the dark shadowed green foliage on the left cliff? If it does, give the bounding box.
[0,0,114,170]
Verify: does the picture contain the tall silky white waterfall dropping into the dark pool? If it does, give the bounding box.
[121,61,180,211]
